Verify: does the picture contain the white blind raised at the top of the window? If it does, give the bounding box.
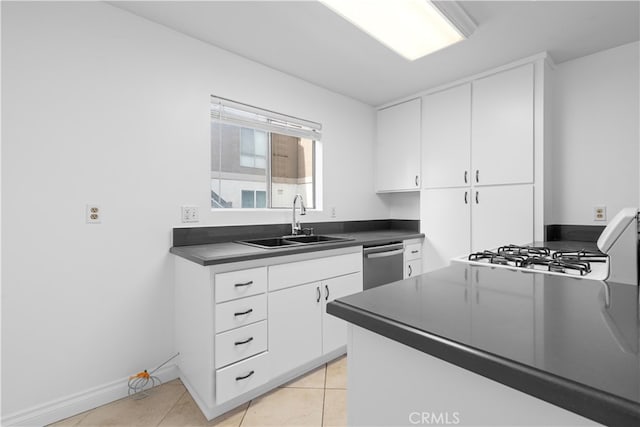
[211,96,322,141]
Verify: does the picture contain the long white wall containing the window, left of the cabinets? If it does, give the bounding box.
[2,2,389,419]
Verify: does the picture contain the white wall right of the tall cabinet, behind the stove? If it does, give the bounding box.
[551,42,640,225]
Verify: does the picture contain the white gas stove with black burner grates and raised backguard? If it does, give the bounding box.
[454,208,638,285]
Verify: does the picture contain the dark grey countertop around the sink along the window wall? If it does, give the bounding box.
[170,230,424,265]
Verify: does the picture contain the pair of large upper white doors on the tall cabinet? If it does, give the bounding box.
[422,64,534,188]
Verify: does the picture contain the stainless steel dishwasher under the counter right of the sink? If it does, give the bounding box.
[362,242,404,290]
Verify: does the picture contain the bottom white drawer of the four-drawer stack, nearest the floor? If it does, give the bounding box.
[215,352,270,405]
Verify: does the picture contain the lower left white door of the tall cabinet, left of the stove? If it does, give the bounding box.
[420,188,471,272]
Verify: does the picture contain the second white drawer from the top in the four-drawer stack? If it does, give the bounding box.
[215,294,267,333]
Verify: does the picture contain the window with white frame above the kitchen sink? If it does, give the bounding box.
[211,97,321,209]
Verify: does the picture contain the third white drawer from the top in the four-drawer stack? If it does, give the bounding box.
[215,320,267,368]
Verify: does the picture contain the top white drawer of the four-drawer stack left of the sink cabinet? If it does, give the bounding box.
[214,267,267,303]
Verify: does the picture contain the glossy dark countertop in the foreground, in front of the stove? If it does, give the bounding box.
[327,262,640,425]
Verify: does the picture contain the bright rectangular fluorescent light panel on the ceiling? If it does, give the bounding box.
[320,0,465,61]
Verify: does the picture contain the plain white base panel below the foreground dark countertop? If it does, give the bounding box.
[347,324,601,426]
